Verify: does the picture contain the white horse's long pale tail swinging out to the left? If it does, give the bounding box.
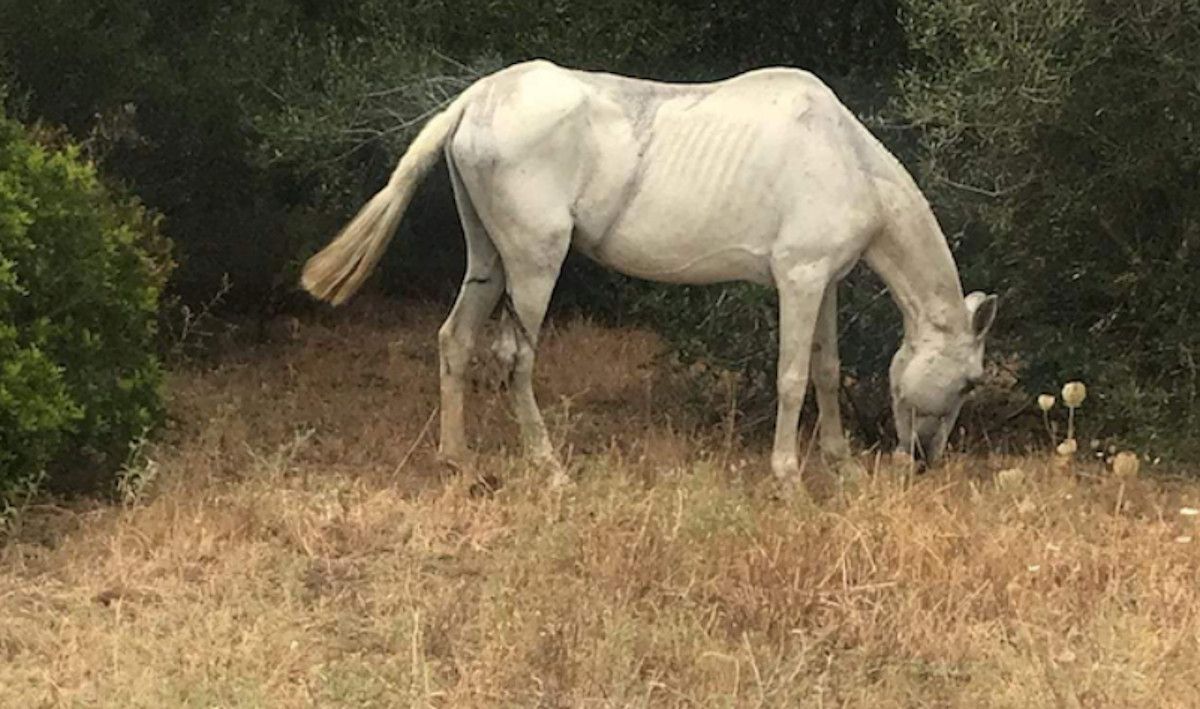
[300,89,470,305]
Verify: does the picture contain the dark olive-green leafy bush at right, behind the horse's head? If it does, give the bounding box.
[899,0,1200,455]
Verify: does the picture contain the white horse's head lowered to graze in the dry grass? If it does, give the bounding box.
[889,292,996,464]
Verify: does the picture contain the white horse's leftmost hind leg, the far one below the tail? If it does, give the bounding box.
[438,163,504,463]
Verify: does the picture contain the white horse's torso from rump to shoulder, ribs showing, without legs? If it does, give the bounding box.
[451,61,892,282]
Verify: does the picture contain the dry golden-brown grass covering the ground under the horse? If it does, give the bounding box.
[0,298,1200,707]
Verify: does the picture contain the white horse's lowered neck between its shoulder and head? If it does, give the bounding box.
[864,185,968,342]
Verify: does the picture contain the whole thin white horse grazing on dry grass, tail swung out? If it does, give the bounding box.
[302,60,996,489]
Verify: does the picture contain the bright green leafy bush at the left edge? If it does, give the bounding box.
[0,115,169,499]
